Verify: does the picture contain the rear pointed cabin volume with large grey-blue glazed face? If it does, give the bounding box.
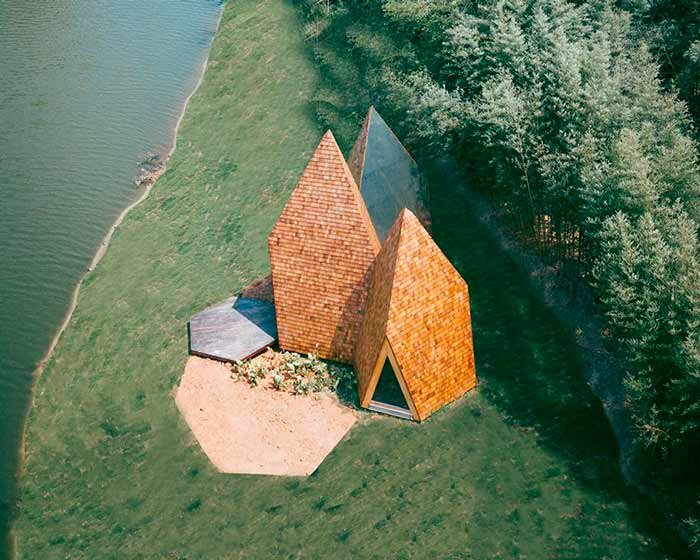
[348,107,423,241]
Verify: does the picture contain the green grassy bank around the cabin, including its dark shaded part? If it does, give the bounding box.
[17,0,680,558]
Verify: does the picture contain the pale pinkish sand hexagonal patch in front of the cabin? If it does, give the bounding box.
[175,356,357,476]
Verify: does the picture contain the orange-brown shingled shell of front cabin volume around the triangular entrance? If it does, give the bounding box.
[354,210,476,420]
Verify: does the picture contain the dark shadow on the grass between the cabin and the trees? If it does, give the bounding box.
[430,162,685,557]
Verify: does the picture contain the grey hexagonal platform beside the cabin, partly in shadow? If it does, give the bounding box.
[188,297,277,362]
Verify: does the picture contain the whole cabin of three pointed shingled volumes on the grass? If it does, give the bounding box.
[268,108,476,421]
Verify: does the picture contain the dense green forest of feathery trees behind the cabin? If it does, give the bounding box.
[305,0,700,551]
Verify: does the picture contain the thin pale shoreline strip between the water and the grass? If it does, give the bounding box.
[7,6,224,558]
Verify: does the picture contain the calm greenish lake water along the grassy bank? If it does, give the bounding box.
[0,0,220,557]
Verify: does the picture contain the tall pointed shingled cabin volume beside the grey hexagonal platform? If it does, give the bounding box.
[268,131,379,362]
